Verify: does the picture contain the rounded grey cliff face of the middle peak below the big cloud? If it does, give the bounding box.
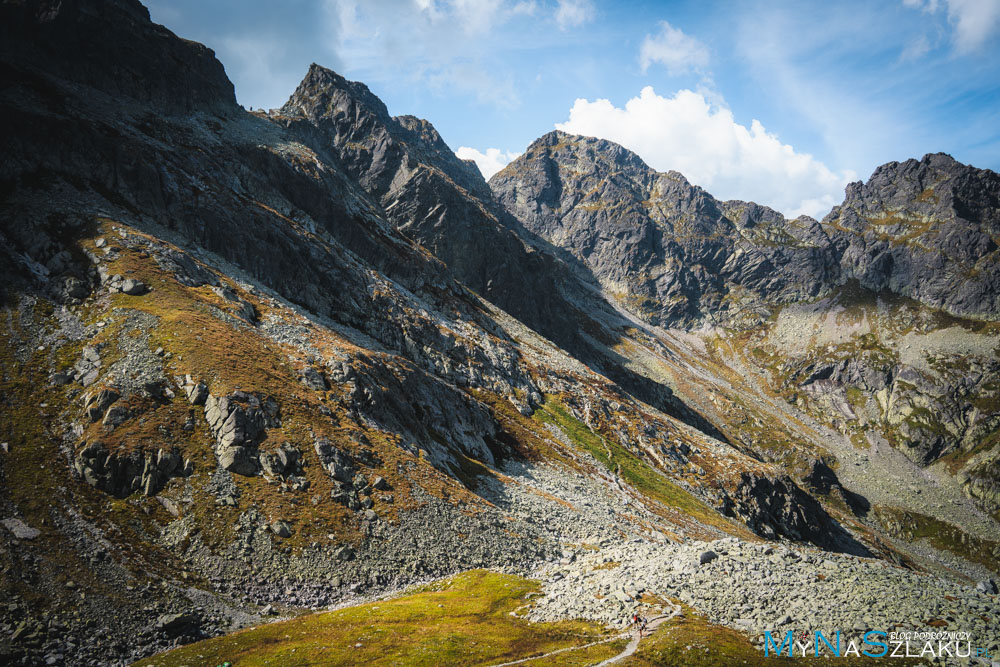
[490,131,839,325]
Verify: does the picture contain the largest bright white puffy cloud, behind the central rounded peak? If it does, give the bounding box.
[556,86,856,217]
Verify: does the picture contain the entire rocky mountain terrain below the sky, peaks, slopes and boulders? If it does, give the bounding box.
[0,0,1000,665]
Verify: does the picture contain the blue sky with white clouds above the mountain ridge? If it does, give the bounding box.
[147,0,1000,217]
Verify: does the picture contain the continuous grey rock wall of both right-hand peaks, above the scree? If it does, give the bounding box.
[490,132,1000,325]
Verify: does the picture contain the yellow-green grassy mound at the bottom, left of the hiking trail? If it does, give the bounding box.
[136,570,625,667]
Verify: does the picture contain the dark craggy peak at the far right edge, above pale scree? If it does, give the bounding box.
[823,153,1000,321]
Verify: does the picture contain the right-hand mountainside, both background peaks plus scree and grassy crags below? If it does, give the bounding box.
[490,131,1000,512]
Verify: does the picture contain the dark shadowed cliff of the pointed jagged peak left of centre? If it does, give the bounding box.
[273,65,598,360]
